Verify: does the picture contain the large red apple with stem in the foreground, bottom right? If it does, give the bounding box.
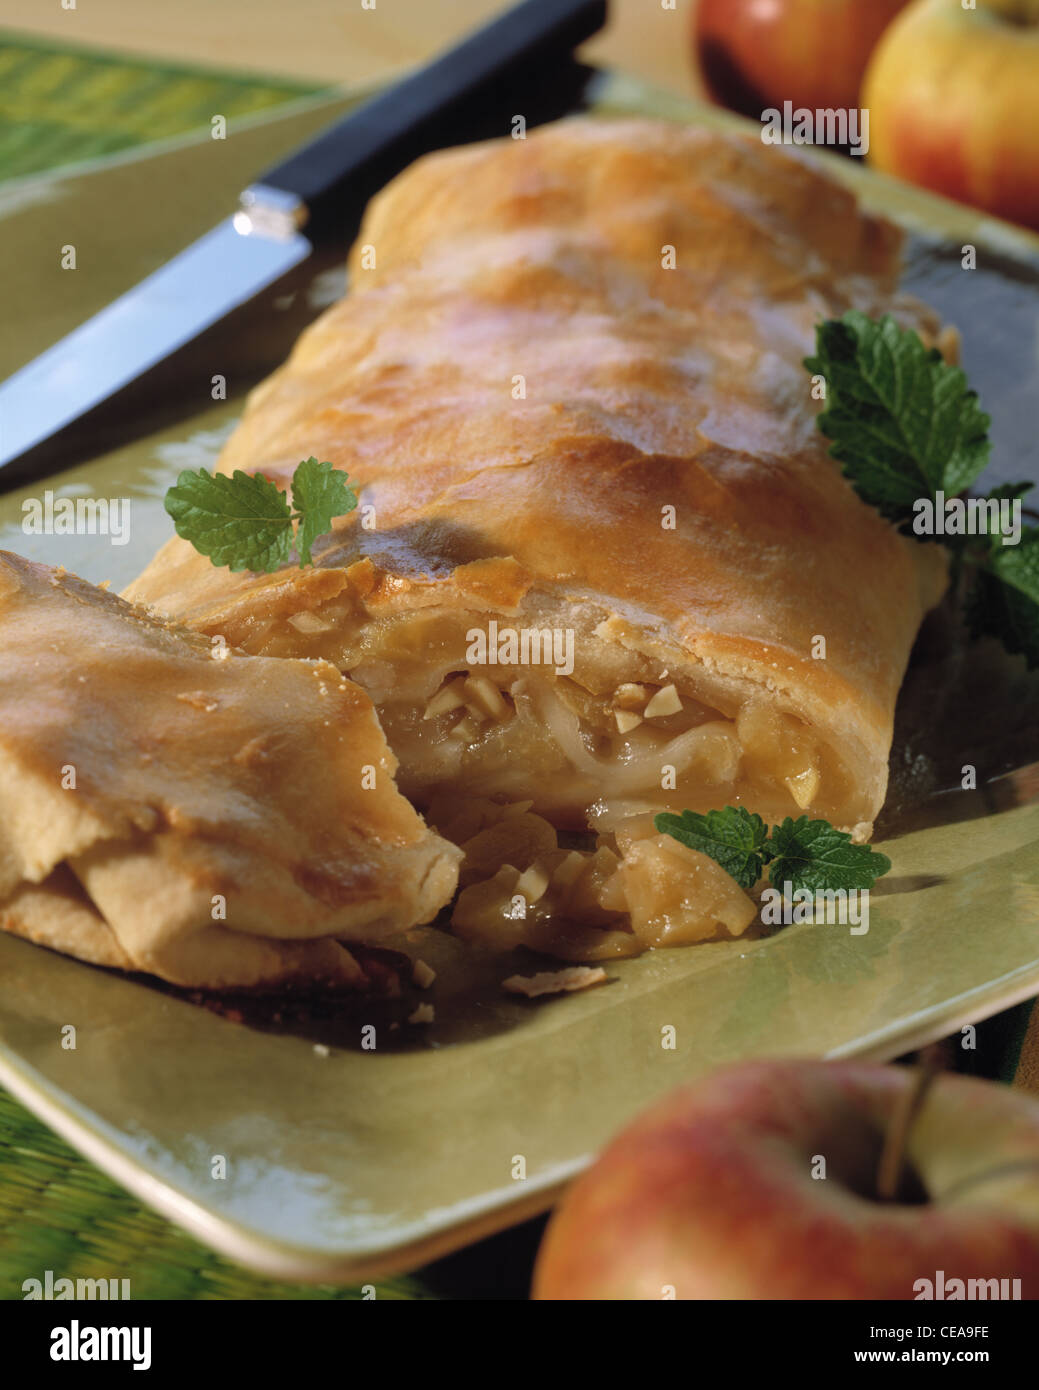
[533,1061,1039,1300]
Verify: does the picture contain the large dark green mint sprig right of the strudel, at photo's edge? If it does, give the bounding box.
[804,309,1039,669]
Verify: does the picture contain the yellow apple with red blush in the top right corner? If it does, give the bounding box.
[862,0,1039,229]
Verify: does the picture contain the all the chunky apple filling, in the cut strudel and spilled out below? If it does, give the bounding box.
[211,591,848,960]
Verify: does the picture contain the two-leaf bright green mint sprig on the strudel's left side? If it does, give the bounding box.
[164,457,357,574]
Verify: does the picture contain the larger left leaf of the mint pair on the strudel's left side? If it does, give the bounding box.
[166,468,292,573]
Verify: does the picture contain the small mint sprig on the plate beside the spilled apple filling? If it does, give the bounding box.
[654,806,892,892]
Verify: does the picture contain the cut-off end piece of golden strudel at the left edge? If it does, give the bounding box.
[0,552,459,988]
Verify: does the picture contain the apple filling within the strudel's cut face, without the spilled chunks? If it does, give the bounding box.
[216,591,847,828]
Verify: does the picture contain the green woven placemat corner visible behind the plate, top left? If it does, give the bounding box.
[0,29,327,181]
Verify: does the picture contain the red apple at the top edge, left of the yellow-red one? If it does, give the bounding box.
[693,0,907,117]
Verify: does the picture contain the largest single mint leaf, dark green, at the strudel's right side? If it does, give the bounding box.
[804,309,992,521]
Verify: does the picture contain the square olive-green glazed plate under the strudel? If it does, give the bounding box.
[0,70,1039,1282]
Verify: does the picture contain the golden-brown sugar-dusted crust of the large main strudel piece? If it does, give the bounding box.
[128,120,946,833]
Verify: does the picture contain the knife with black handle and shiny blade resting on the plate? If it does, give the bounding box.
[0,0,606,492]
